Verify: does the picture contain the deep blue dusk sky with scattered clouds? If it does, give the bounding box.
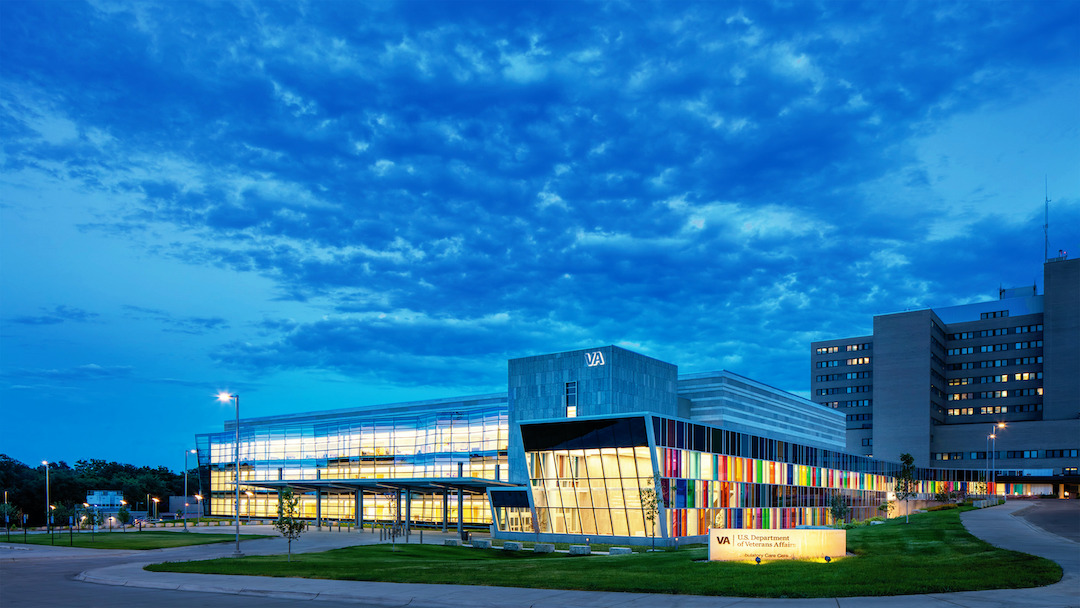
[0,0,1080,470]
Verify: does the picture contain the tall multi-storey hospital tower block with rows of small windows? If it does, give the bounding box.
[810,257,1080,498]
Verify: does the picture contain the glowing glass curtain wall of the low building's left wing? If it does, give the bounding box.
[197,400,509,524]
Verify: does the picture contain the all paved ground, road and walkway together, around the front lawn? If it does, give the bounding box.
[0,500,1080,608]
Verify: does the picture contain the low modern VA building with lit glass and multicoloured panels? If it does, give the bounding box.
[197,346,978,543]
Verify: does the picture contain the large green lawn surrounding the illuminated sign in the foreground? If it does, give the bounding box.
[147,510,1062,597]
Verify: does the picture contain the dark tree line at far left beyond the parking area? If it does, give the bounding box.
[0,454,199,526]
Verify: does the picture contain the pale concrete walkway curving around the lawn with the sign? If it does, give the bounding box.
[56,501,1080,608]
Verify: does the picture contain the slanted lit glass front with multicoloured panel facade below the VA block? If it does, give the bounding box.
[496,416,978,538]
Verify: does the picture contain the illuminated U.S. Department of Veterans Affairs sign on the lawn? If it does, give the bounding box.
[708,528,848,562]
